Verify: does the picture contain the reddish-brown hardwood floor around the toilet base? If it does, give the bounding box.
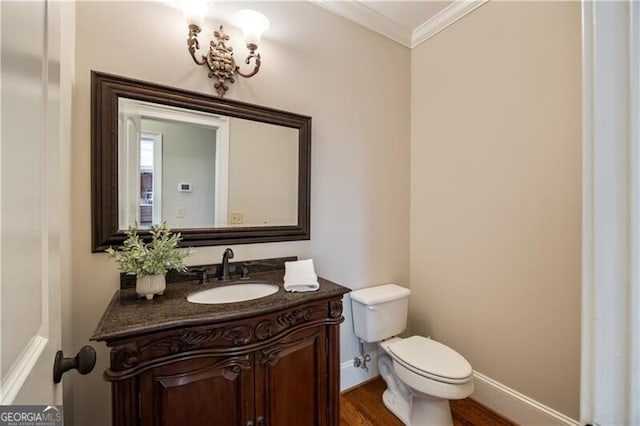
[340,377,516,426]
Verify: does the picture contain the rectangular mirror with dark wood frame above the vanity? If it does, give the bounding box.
[91,71,311,252]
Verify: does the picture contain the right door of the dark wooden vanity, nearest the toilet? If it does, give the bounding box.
[255,326,328,426]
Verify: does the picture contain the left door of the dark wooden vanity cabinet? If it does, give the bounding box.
[140,355,254,426]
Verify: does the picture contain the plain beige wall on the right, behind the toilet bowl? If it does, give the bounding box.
[410,2,581,419]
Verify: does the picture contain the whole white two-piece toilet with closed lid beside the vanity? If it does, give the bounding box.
[351,284,473,426]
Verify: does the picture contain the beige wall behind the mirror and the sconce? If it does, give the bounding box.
[70,1,409,426]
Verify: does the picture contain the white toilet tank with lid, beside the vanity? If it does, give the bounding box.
[350,284,411,343]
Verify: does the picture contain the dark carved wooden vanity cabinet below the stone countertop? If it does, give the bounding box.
[105,298,343,426]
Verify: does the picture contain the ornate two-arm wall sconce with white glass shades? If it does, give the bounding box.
[183,0,269,97]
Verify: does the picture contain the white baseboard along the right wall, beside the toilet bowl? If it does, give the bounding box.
[471,371,580,426]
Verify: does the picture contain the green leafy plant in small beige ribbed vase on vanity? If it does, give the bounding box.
[106,222,194,300]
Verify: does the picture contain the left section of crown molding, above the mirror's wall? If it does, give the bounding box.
[310,0,411,48]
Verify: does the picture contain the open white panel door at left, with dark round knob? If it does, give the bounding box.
[0,0,69,405]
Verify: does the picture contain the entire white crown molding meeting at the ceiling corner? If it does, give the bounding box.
[310,0,489,49]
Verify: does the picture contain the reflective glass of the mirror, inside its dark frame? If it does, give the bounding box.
[118,98,298,230]
